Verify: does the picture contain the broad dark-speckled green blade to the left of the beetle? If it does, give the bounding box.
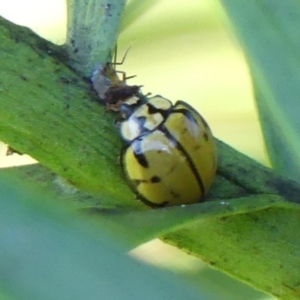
[0,14,142,207]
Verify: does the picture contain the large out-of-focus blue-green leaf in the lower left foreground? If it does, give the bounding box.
[0,178,208,300]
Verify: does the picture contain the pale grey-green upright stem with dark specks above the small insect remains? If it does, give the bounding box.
[65,0,126,77]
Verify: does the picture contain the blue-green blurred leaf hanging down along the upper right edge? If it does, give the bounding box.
[221,0,300,181]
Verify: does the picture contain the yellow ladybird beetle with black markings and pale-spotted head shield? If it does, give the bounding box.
[119,95,217,207]
